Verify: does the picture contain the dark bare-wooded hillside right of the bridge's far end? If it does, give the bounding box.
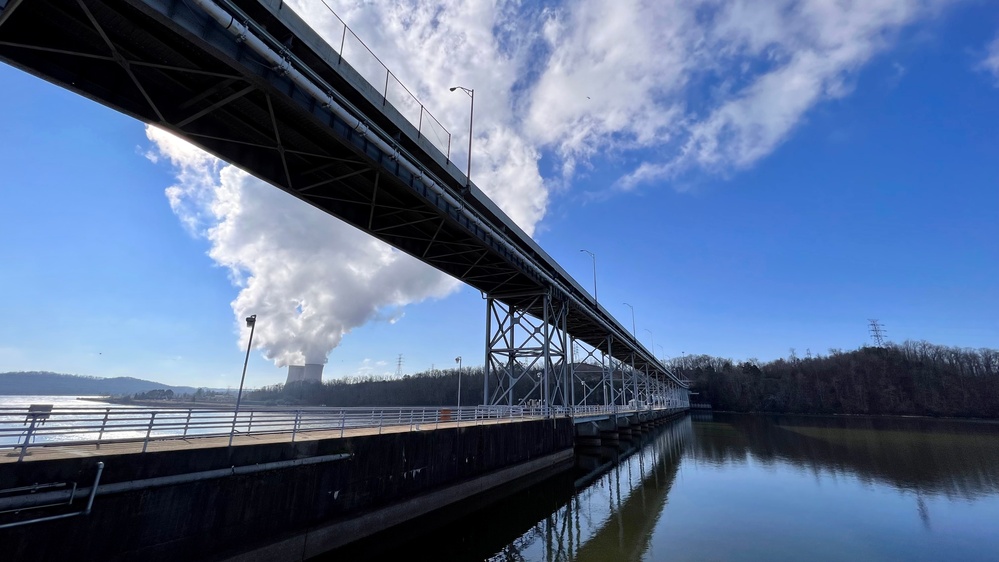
[681,341,999,418]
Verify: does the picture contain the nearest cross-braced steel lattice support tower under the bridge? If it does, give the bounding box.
[483,293,572,410]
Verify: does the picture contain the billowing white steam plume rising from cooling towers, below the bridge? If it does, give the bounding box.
[146,127,458,366]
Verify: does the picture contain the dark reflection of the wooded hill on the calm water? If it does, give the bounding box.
[692,414,999,499]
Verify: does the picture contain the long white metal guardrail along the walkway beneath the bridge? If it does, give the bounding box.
[0,404,623,462]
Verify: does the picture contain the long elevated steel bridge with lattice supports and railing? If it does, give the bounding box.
[0,0,688,408]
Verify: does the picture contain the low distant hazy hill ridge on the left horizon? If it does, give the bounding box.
[0,371,197,396]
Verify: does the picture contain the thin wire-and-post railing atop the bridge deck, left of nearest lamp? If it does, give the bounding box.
[317,1,451,160]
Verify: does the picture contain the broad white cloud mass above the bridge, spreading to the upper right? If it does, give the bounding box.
[282,0,952,190]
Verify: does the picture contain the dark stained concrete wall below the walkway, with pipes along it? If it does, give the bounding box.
[0,419,573,562]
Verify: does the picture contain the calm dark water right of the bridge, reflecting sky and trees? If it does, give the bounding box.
[328,414,999,561]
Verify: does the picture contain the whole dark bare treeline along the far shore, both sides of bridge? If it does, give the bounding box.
[246,341,999,418]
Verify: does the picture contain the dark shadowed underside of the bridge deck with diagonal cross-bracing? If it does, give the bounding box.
[0,0,539,293]
